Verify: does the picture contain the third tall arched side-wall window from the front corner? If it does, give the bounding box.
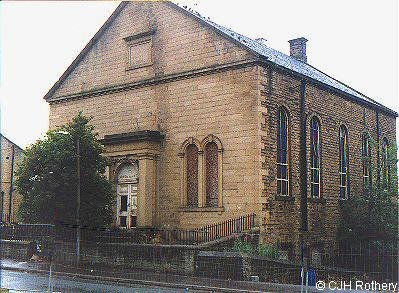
[339,125,349,199]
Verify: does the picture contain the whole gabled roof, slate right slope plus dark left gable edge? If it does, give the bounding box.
[44,1,398,117]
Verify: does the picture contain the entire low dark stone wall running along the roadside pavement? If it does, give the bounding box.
[0,240,388,284]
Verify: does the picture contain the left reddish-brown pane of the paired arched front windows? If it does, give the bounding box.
[185,144,198,207]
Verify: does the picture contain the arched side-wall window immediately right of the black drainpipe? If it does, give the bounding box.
[310,117,321,198]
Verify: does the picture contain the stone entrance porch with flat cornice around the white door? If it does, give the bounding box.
[101,130,163,229]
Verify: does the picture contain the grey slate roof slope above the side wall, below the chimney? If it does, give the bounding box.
[175,4,398,116]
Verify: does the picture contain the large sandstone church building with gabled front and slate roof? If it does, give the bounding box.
[44,2,397,249]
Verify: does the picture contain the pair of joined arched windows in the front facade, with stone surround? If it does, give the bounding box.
[180,135,223,208]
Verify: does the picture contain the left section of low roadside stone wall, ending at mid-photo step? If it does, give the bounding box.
[0,240,198,274]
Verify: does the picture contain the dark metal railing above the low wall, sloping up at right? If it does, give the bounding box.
[2,214,255,245]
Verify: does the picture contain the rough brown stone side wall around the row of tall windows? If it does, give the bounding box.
[259,67,396,253]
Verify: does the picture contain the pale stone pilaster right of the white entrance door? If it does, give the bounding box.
[137,155,156,227]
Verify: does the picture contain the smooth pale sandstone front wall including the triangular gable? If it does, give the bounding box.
[50,2,260,228]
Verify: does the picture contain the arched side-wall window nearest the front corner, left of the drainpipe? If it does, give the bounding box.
[277,108,289,196]
